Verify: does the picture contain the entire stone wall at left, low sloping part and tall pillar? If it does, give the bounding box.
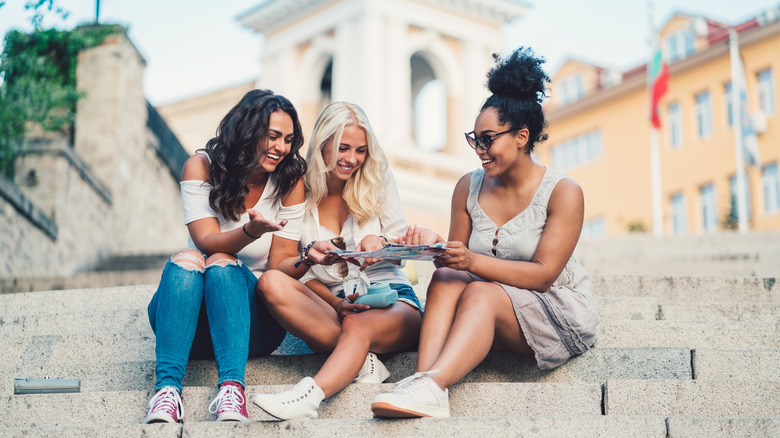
[0,31,187,278]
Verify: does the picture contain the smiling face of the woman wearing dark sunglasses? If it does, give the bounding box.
[474,107,528,176]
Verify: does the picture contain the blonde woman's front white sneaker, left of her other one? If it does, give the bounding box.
[252,377,325,420]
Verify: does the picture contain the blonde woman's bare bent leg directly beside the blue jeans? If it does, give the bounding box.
[257,270,341,352]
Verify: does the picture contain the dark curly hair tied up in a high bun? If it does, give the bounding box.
[480,47,550,154]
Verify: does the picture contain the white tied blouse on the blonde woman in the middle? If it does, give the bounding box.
[300,171,411,294]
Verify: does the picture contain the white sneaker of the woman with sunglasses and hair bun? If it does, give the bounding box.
[371,370,450,418]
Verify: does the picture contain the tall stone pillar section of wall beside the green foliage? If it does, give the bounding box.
[74,36,187,254]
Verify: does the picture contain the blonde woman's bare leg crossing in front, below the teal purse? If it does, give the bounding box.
[314,301,422,397]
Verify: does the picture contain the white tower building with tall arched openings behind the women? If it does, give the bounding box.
[238,0,526,233]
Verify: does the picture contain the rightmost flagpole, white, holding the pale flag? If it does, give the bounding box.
[729,28,748,234]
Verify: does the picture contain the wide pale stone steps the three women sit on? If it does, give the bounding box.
[0,273,780,438]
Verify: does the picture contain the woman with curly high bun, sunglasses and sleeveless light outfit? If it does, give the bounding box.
[371,47,600,417]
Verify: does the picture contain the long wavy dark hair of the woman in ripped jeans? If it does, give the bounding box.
[205,90,306,221]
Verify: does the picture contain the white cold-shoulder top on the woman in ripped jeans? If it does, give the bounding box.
[180,154,305,275]
